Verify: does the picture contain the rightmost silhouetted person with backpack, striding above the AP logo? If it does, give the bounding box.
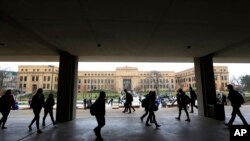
[224,84,248,126]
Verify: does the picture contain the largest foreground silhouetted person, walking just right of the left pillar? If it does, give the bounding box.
[91,91,106,141]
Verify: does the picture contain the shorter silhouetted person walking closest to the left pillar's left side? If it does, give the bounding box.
[43,94,56,126]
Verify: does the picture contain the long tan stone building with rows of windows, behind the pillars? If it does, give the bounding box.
[17,66,229,93]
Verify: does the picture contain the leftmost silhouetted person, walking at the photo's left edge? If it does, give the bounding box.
[0,89,15,129]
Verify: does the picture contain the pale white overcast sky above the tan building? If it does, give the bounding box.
[0,62,250,78]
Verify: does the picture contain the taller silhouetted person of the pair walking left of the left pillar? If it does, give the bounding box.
[29,88,44,134]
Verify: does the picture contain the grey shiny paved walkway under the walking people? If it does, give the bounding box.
[0,106,250,141]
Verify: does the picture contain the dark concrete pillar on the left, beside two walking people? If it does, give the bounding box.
[56,52,78,122]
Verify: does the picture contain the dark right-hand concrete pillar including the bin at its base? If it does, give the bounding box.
[194,55,225,120]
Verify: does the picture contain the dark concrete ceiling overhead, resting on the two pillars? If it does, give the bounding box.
[0,0,250,62]
